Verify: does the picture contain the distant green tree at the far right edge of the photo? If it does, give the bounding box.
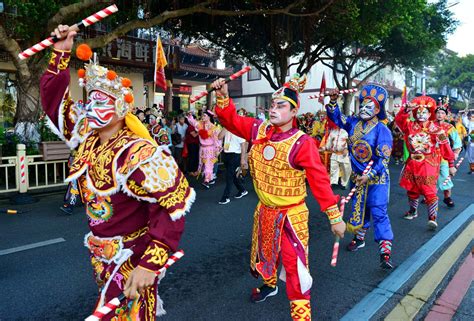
[431,54,474,108]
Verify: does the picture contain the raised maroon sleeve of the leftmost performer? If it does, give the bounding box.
[40,49,87,148]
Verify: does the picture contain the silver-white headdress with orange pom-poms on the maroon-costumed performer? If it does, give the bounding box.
[76,44,134,117]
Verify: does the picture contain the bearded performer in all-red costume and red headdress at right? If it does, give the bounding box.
[395,96,456,230]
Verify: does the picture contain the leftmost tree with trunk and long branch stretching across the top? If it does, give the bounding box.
[0,0,314,140]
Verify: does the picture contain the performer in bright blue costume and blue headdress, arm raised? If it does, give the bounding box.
[326,84,393,269]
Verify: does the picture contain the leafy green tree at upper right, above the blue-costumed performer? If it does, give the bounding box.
[323,0,456,114]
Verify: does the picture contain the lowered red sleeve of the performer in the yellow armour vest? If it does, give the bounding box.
[293,136,342,224]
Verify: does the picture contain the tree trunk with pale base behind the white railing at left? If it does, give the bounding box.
[15,73,42,143]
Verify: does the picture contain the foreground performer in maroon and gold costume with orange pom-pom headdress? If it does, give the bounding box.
[41,25,195,321]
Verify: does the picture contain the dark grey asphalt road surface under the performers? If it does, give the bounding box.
[0,162,474,321]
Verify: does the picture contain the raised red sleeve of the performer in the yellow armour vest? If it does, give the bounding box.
[215,98,262,141]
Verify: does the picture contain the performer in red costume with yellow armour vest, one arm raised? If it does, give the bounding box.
[212,77,346,320]
